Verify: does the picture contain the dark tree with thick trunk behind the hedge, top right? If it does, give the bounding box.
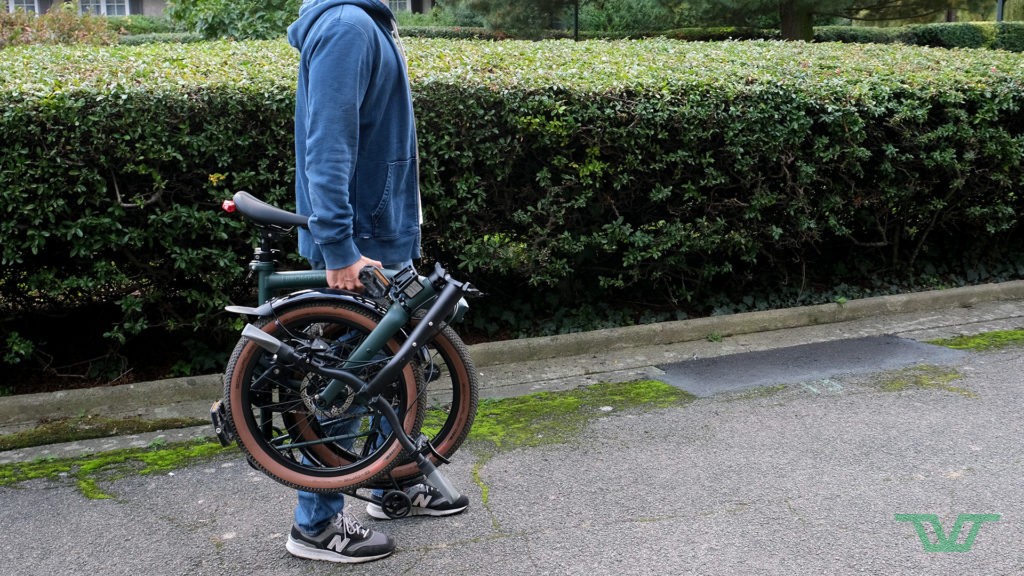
[664,0,992,40]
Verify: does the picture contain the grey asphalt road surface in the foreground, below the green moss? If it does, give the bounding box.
[0,342,1024,576]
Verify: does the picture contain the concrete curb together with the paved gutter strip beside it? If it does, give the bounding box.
[0,281,1024,464]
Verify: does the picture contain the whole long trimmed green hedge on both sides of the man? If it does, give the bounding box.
[0,38,1024,381]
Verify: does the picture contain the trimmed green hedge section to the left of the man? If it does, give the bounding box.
[0,43,295,375]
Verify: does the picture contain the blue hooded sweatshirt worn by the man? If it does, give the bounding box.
[288,0,420,270]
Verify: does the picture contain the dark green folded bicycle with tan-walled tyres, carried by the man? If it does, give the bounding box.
[211,192,479,518]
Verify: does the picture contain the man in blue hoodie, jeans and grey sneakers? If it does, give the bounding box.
[287,0,468,563]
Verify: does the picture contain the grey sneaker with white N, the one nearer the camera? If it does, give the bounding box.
[285,511,394,564]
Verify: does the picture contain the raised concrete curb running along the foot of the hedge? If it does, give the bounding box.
[0,281,1024,434]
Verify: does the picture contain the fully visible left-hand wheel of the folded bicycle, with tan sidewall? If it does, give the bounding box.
[224,302,424,492]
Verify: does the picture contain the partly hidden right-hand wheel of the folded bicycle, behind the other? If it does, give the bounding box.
[381,326,479,487]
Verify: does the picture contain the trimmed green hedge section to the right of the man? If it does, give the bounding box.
[414,41,1024,302]
